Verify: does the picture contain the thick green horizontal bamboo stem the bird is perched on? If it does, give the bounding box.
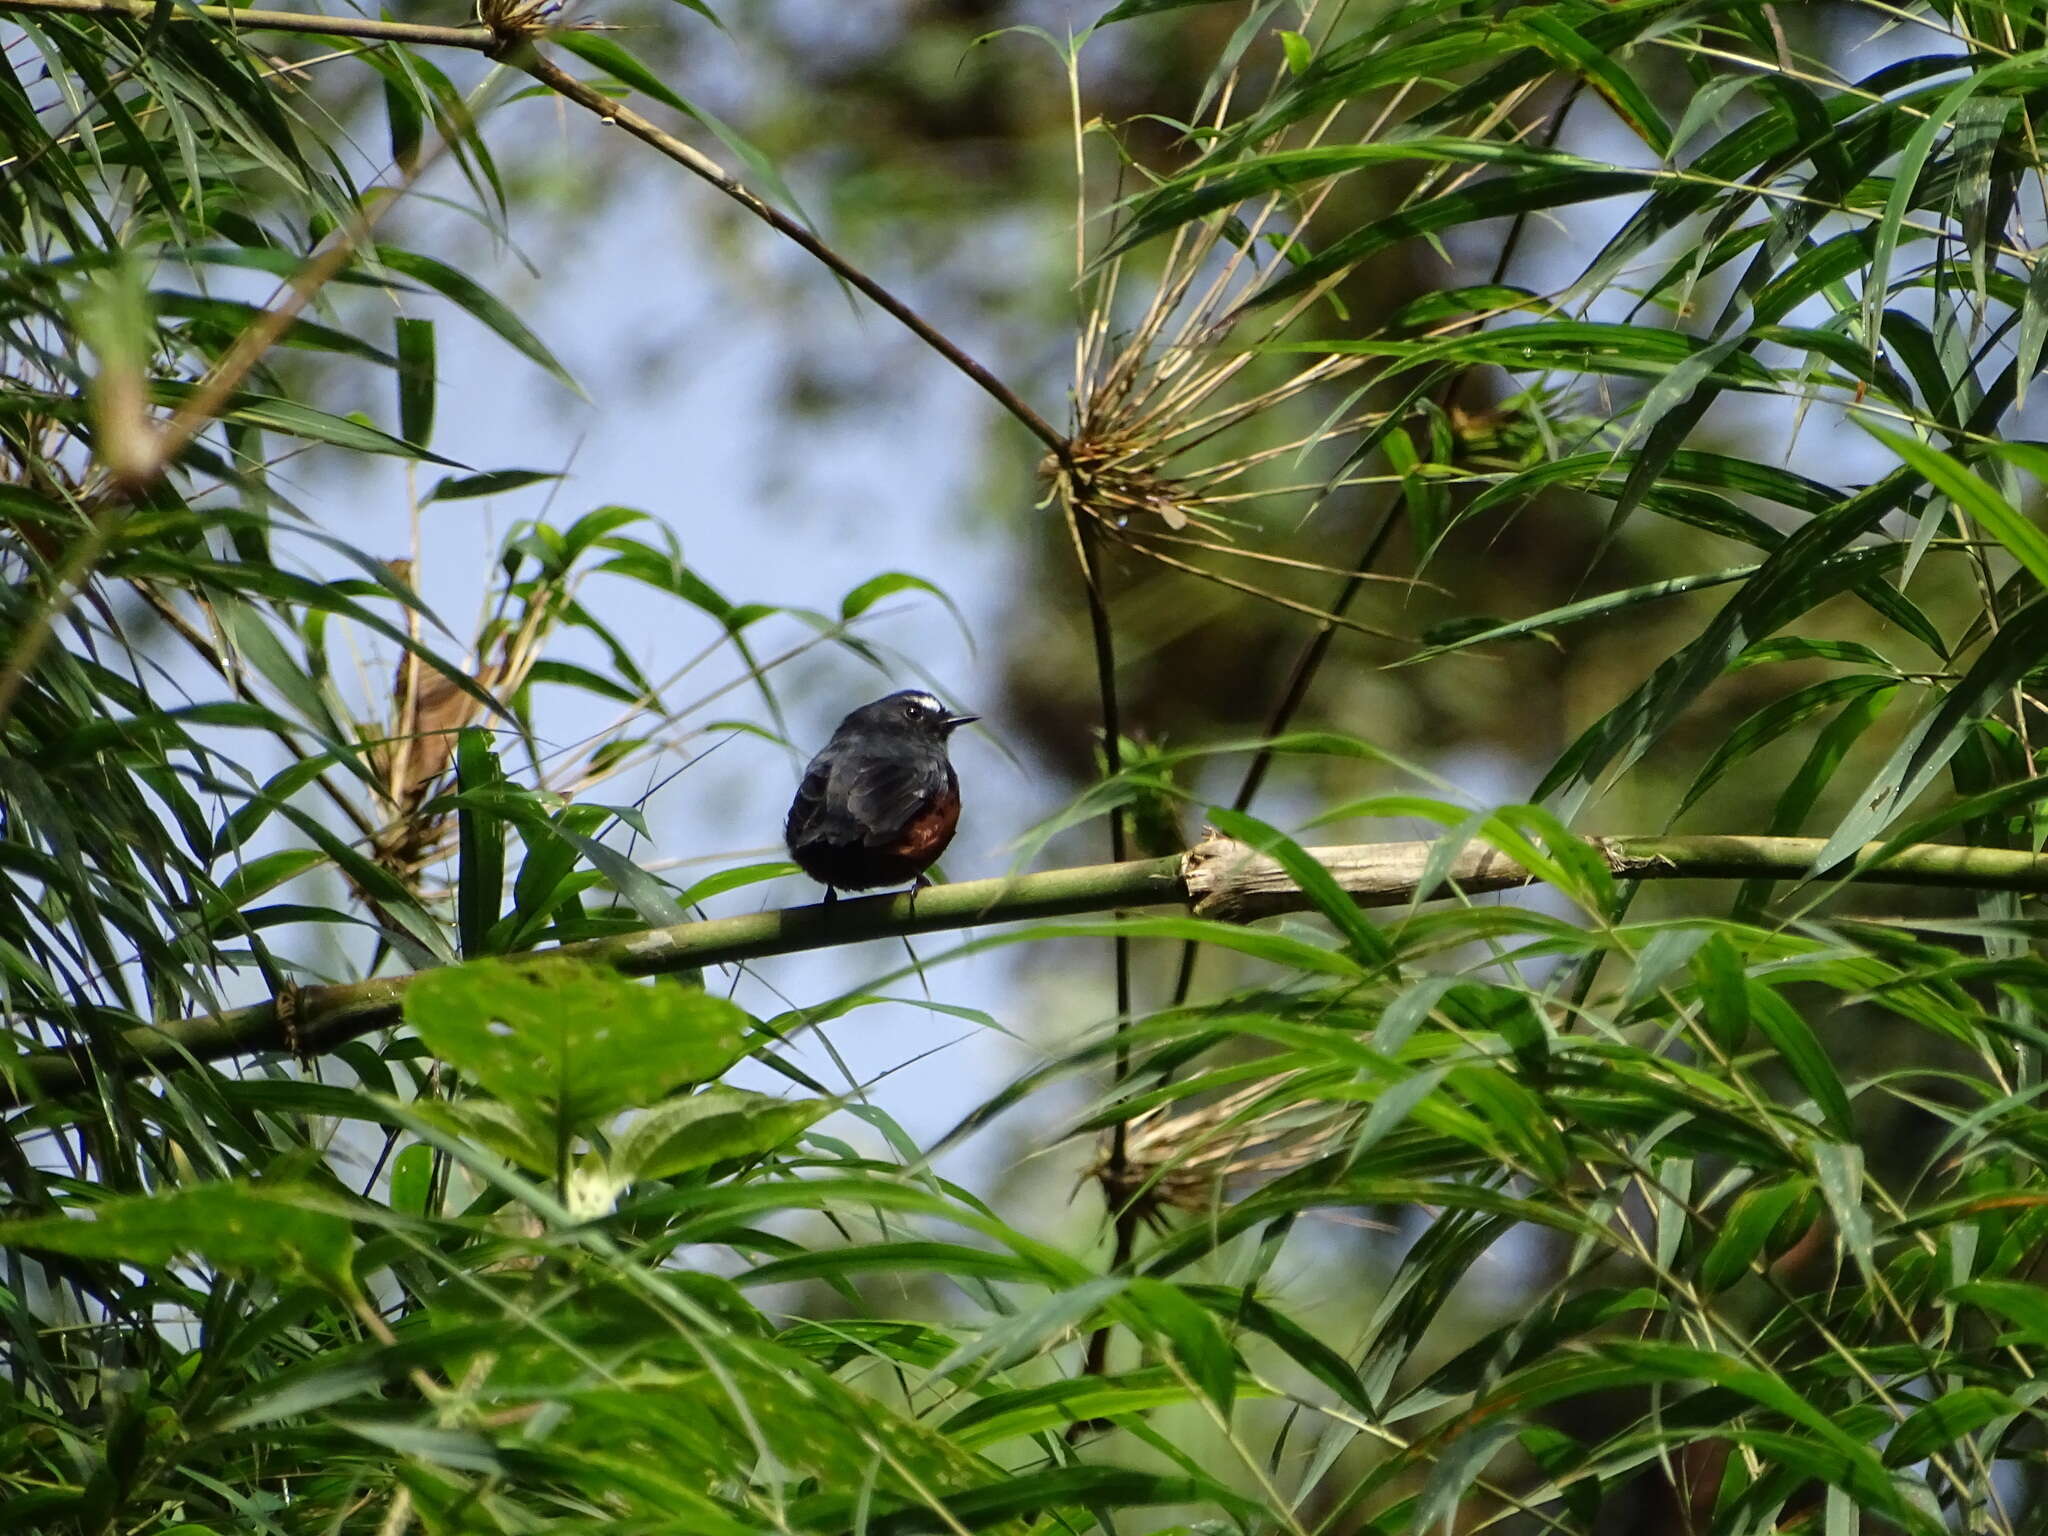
[0,834,2048,1106]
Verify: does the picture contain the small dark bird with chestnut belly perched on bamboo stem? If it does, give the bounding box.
[782,688,981,903]
